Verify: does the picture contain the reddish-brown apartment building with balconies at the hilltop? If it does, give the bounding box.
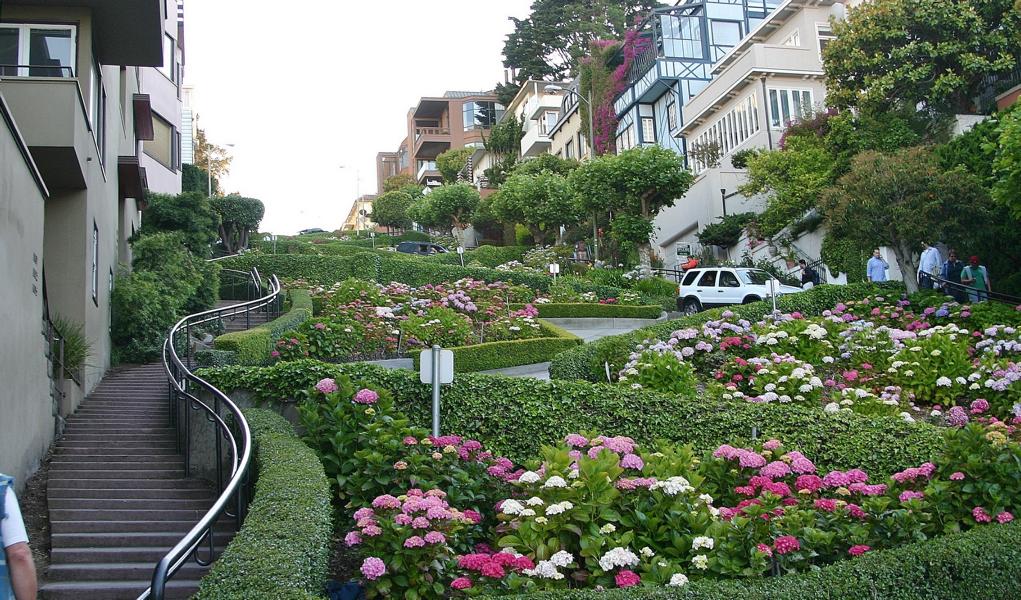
[376,91,504,193]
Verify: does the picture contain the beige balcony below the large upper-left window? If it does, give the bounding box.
[0,78,99,190]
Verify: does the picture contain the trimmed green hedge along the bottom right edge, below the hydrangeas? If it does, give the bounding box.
[487,522,1021,600]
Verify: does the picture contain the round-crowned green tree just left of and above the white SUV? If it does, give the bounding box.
[569,146,693,265]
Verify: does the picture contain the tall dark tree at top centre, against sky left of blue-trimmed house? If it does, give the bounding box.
[503,0,662,83]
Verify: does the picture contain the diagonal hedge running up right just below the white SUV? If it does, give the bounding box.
[549,283,904,382]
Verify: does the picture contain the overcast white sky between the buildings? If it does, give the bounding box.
[185,0,531,234]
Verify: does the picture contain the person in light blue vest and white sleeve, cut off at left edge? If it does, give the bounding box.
[0,473,39,600]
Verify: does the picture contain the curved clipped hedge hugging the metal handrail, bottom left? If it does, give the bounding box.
[195,408,333,600]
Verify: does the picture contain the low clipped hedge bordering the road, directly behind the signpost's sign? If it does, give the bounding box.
[412,321,582,372]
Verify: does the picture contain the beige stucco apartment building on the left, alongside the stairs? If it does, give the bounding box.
[0,0,173,485]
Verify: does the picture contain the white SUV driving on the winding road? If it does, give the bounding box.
[677,266,801,314]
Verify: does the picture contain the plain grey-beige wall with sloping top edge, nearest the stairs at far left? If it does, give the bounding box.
[0,93,54,489]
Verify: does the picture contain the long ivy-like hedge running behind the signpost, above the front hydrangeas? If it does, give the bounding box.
[200,360,942,478]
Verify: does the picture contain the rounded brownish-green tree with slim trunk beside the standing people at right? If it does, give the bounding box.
[820,146,989,292]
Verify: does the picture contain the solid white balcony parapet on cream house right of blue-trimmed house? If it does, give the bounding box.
[680,44,823,135]
